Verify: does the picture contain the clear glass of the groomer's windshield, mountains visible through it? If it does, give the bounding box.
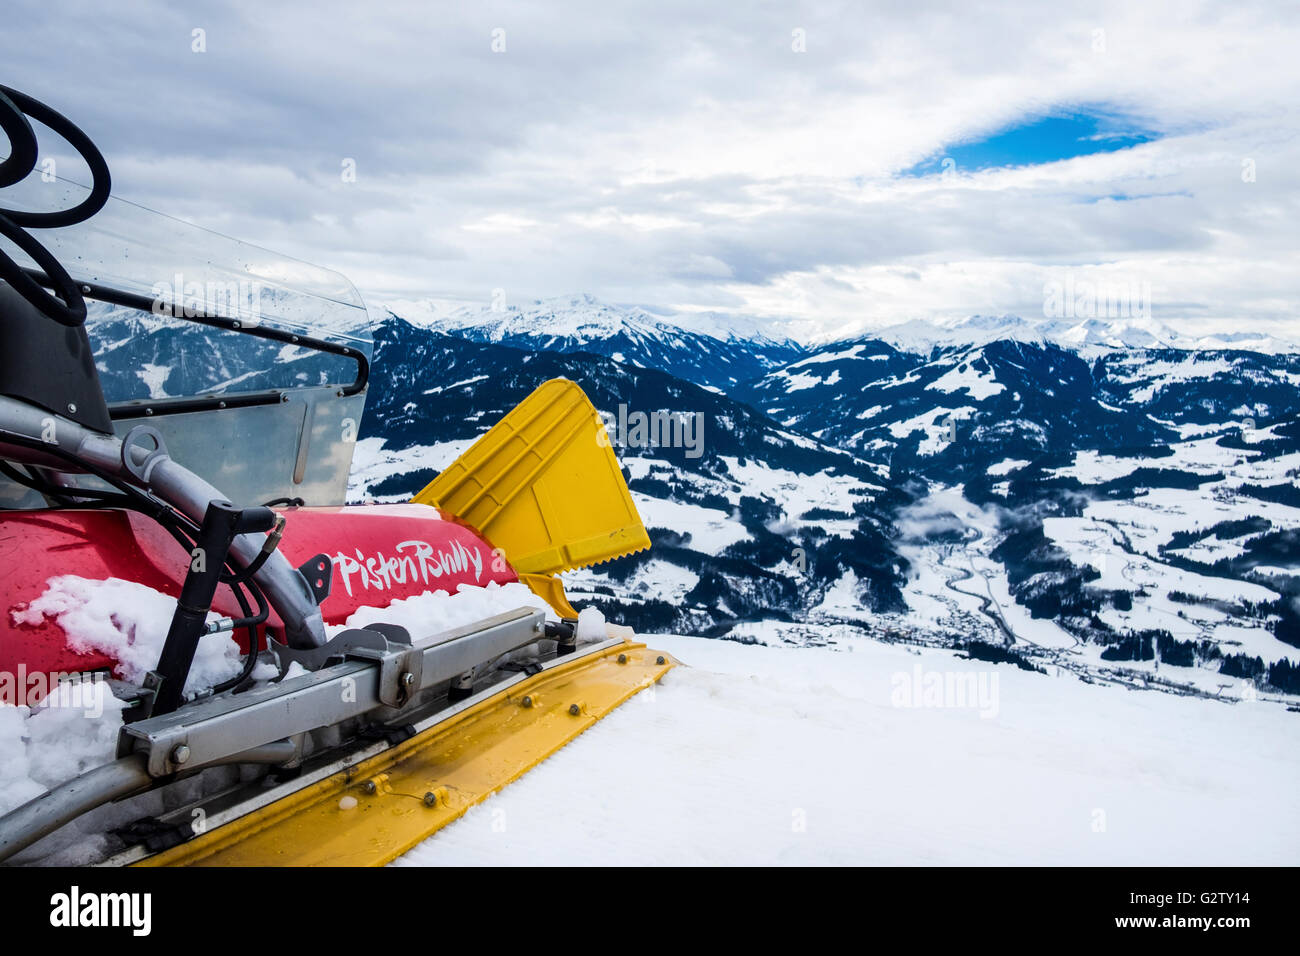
[4,176,373,402]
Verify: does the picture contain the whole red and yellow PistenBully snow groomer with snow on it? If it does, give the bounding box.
[0,87,675,865]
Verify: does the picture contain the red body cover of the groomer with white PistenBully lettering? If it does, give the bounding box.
[0,505,519,674]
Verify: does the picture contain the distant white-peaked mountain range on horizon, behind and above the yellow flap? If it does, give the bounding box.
[421,295,805,392]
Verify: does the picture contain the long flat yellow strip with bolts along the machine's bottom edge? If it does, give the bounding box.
[137,640,677,866]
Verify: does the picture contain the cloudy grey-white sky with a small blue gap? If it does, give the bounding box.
[0,0,1300,337]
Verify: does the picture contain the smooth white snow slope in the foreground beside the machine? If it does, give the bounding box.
[395,637,1300,866]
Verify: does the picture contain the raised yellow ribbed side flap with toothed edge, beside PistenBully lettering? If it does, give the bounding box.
[413,378,650,580]
